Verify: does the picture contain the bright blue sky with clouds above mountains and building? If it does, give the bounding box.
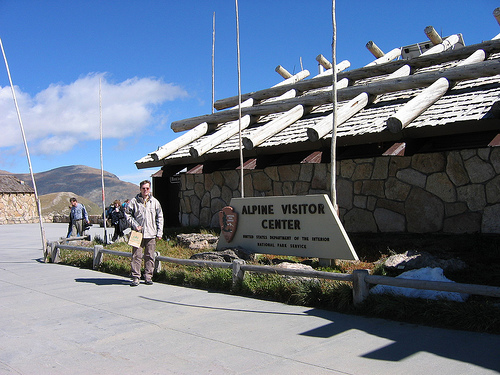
[0,0,500,184]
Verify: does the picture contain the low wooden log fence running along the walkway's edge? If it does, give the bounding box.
[48,242,500,304]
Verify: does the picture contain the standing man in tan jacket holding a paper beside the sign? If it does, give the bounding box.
[125,180,163,286]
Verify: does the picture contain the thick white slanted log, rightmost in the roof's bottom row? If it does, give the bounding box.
[387,77,450,133]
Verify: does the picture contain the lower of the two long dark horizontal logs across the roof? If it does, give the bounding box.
[171,60,500,132]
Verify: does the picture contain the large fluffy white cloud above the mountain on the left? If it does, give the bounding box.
[0,74,187,155]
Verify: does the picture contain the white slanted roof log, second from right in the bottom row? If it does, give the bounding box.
[306,92,369,142]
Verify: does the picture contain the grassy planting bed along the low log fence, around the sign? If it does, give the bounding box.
[61,232,500,334]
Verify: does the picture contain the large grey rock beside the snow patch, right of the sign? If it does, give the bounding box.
[384,250,467,272]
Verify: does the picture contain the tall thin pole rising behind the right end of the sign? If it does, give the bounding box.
[330,0,338,213]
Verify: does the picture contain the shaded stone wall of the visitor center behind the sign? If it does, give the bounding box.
[179,148,500,233]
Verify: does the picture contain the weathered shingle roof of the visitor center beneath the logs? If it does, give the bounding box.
[136,34,500,168]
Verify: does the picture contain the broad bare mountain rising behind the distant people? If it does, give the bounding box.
[14,165,139,208]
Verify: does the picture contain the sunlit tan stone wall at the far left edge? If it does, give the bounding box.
[0,193,39,224]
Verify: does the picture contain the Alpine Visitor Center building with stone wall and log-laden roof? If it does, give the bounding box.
[136,12,500,234]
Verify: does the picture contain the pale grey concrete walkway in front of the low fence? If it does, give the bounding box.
[0,224,500,375]
